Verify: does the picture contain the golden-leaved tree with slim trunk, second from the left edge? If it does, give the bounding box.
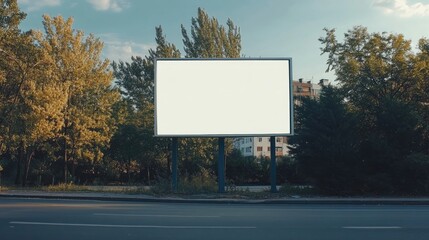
[37,16,118,182]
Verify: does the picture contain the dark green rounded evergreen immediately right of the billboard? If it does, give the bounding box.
[290,86,364,194]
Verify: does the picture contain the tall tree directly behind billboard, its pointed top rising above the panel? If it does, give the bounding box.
[177,8,241,179]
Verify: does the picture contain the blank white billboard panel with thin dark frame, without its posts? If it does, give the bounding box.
[155,58,292,137]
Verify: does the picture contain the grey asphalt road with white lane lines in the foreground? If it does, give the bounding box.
[0,198,429,240]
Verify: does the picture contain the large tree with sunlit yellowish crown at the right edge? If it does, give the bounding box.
[319,27,429,194]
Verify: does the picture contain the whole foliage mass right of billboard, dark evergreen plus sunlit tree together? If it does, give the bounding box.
[286,27,429,195]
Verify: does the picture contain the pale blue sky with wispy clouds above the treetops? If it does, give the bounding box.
[18,0,429,83]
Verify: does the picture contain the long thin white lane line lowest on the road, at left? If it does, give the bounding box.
[9,222,256,229]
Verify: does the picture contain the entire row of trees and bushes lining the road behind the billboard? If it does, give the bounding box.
[0,0,429,197]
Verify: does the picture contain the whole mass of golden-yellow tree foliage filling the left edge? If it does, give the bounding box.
[0,0,118,187]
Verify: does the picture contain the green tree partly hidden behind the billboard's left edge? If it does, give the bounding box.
[111,26,180,184]
